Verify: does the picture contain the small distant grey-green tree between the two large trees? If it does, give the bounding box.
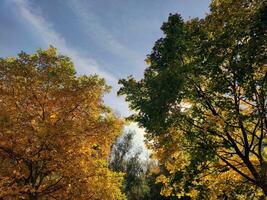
[110,131,170,200]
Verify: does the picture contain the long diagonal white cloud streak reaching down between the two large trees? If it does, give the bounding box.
[12,0,129,116]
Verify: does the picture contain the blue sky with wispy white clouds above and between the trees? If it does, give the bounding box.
[0,0,210,155]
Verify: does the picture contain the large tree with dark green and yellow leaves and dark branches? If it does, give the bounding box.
[119,0,267,198]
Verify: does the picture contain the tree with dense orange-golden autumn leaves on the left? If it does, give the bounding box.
[0,47,125,199]
